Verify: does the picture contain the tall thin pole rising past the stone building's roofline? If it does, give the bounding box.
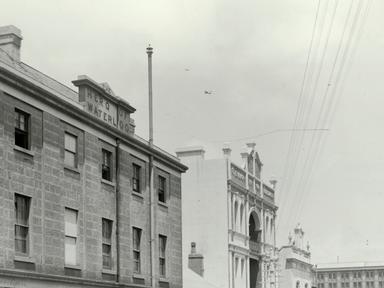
[147,46,156,288]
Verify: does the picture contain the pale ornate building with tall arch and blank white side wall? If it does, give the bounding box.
[176,143,277,288]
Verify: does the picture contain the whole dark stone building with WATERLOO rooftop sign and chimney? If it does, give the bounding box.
[0,26,187,288]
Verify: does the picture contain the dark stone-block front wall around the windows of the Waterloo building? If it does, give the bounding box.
[0,92,182,287]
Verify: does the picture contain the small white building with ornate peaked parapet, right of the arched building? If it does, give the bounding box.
[279,224,314,288]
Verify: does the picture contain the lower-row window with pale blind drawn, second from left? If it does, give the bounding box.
[64,208,77,265]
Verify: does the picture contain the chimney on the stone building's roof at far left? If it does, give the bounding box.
[0,25,23,62]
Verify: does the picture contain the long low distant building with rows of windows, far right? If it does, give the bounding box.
[315,262,384,288]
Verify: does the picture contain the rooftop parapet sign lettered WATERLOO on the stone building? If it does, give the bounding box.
[73,76,134,134]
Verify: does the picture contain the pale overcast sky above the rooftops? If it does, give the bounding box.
[0,0,384,263]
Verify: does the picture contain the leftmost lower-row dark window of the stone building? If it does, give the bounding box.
[15,194,31,254]
